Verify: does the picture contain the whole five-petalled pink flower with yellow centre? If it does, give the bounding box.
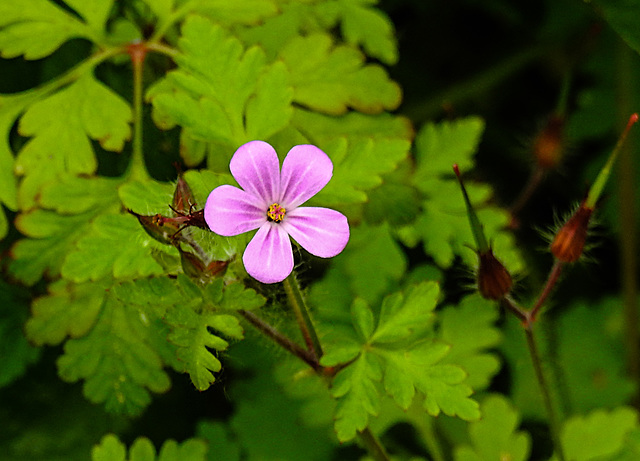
[204,141,349,283]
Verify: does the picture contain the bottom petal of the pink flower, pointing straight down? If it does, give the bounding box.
[242,222,293,283]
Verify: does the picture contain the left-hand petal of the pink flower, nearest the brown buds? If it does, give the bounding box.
[204,185,267,236]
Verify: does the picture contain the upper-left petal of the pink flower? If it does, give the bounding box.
[229,141,280,205]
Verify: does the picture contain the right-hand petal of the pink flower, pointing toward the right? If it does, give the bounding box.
[280,207,349,258]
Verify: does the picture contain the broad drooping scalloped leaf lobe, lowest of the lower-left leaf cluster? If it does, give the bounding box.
[58,295,170,415]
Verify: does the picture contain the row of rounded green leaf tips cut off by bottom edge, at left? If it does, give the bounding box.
[91,434,207,461]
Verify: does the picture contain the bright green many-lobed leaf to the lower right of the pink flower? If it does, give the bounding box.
[321,282,480,441]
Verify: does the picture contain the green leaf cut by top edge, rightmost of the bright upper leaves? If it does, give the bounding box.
[316,0,398,65]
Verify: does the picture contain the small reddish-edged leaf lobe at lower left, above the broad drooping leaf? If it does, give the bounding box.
[25,280,108,345]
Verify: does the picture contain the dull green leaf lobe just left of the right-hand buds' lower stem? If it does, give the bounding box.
[437,294,502,391]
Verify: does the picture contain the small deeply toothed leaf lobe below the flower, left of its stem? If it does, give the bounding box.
[165,307,243,391]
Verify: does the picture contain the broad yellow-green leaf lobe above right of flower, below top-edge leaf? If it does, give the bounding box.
[280,34,402,115]
